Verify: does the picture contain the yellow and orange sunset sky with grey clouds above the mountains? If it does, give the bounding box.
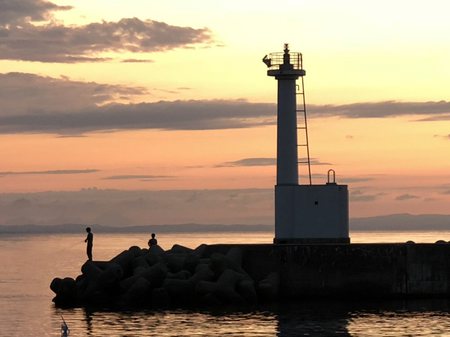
[0,0,450,226]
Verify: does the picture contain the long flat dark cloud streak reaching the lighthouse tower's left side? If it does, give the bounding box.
[0,100,275,134]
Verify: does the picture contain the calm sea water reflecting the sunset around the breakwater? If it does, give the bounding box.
[0,232,450,337]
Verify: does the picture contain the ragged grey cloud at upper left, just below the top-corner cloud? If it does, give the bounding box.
[0,17,212,63]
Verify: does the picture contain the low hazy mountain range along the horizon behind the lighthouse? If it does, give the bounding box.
[0,214,450,234]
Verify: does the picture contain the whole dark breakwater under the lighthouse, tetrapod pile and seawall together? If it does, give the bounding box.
[50,244,450,308]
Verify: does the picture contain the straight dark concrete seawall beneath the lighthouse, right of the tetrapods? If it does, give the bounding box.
[208,242,450,299]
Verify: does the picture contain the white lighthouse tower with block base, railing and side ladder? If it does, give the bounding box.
[263,44,350,243]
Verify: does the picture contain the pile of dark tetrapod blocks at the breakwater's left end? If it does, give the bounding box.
[50,240,270,308]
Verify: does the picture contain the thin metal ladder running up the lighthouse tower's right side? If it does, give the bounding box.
[296,76,312,185]
